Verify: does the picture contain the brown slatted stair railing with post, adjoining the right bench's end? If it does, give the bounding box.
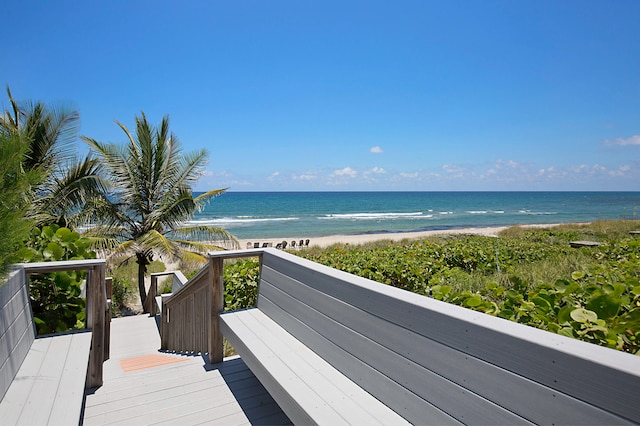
[160,250,262,363]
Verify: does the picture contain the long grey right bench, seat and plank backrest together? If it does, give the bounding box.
[218,249,640,424]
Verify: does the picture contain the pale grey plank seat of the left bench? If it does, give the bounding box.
[0,331,91,425]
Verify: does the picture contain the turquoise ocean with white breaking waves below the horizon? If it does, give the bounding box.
[193,192,640,239]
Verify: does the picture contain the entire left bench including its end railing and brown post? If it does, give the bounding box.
[0,260,111,424]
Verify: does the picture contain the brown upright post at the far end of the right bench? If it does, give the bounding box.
[207,256,224,364]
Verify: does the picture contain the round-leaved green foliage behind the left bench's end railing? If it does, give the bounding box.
[18,225,96,334]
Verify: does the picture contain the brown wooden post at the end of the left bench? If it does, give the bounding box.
[87,264,109,388]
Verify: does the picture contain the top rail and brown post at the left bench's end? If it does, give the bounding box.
[18,259,111,388]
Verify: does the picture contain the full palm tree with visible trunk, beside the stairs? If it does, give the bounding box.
[82,112,238,306]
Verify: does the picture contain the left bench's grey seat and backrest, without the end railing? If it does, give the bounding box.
[0,265,104,425]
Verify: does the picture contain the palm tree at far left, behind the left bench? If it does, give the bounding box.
[0,86,105,227]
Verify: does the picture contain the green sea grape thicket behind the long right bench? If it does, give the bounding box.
[224,225,640,354]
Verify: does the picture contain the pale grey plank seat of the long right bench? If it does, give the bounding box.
[220,309,408,425]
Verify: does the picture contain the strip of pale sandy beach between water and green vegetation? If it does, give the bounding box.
[238,223,560,249]
